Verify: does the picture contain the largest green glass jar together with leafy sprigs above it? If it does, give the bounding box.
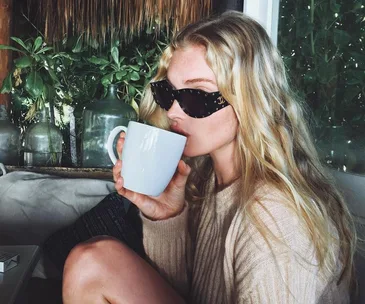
[81,37,165,168]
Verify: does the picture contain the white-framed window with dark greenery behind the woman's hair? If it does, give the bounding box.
[244,0,365,174]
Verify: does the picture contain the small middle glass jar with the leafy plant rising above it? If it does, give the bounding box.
[0,36,62,166]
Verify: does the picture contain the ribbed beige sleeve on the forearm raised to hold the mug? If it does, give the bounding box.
[141,205,191,297]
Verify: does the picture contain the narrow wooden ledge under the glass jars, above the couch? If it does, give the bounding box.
[5,166,113,181]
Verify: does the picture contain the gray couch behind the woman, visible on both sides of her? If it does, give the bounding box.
[0,167,365,304]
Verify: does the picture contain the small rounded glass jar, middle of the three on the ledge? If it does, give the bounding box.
[24,107,62,167]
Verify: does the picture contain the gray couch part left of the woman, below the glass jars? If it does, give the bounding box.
[0,170,114,278]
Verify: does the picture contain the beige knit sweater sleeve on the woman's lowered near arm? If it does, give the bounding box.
[229,190,319,304]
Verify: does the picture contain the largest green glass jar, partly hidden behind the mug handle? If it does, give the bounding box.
[81,85,137,168]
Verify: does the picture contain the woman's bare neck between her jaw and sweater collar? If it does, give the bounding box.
[210,141,241,188]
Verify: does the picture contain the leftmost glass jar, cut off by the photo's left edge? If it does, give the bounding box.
[0,105,20,166]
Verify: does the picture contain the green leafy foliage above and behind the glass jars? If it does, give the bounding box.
[0,27,167,165]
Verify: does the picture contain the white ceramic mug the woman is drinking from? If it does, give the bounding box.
[107,121,186,196]
